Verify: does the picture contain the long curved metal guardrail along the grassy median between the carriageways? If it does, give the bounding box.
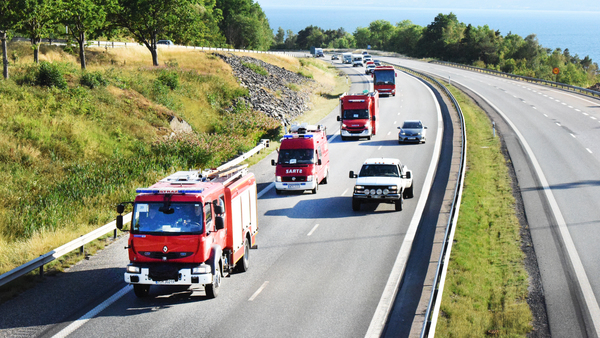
[386,62,467,338]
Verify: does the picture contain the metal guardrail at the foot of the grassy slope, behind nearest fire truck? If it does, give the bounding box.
[0,139,269,286]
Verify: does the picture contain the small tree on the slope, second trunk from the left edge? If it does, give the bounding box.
[15,0,61,63]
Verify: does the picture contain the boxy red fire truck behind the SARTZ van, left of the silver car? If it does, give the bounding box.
[337,91,379,140]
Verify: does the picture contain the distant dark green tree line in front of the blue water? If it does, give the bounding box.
[273,13,600,87]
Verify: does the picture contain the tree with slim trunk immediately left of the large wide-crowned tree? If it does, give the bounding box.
[60,0,112,69]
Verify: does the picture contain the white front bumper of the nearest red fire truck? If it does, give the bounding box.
[125,264,213,285]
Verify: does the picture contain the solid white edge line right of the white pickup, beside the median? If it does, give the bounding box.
[365,71,444,338]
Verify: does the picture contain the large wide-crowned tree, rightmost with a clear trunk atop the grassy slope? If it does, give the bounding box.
[109,0,220,66]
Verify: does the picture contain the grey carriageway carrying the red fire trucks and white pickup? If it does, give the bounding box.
[0,56,452,337]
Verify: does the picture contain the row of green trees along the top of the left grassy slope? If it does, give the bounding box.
[0,0,273,79]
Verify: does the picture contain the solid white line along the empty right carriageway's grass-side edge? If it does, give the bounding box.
[463,84,600,337]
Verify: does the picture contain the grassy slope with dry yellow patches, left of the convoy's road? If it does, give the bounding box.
[0,43,341,296]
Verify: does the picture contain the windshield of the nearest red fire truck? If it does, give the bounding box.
[132,202,204,233]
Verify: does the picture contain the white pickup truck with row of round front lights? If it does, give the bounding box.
[349,158,414,211]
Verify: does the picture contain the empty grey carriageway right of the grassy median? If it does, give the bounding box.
[382,58,600,337]
